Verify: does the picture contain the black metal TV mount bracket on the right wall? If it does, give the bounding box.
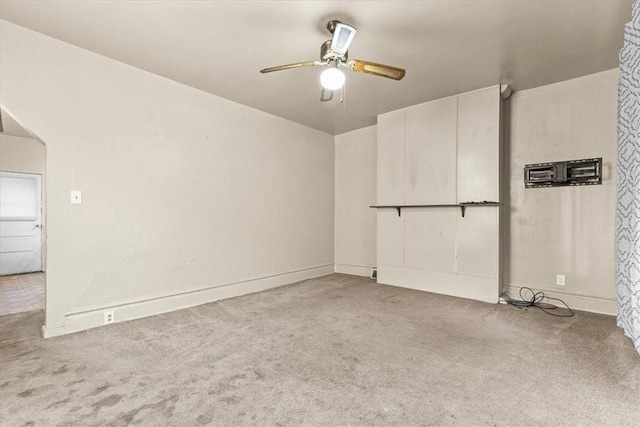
[524,157,602,188]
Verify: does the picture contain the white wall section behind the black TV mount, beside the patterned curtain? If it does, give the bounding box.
[504,70,618,314]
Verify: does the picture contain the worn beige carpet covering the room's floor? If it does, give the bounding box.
[0,274,640,427]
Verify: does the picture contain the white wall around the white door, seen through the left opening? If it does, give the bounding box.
[0,133,47,270]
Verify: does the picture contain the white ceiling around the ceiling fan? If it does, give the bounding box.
[0,0,633,134]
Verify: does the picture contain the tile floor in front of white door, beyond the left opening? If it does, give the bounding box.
[0,273,44,316]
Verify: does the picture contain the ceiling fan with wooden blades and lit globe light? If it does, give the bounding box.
[260,19,405,101]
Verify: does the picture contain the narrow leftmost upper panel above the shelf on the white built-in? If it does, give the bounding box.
[377,110,404,205]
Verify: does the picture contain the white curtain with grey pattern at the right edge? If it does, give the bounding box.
[616,1,640,352]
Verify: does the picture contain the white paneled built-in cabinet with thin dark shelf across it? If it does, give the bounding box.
[377,86,502,302]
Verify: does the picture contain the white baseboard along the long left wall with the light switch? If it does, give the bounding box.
[42,264,334,338]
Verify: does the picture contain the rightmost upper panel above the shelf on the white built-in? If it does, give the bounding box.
[458,86,500,203]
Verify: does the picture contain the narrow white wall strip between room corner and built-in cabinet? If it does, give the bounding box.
[335,126,376,276]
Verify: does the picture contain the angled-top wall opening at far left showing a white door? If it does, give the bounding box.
[0,106,47,332]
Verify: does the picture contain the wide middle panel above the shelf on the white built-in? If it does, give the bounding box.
[404,97,458,205]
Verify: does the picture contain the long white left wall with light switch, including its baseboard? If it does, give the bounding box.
[0,21,334,336]
